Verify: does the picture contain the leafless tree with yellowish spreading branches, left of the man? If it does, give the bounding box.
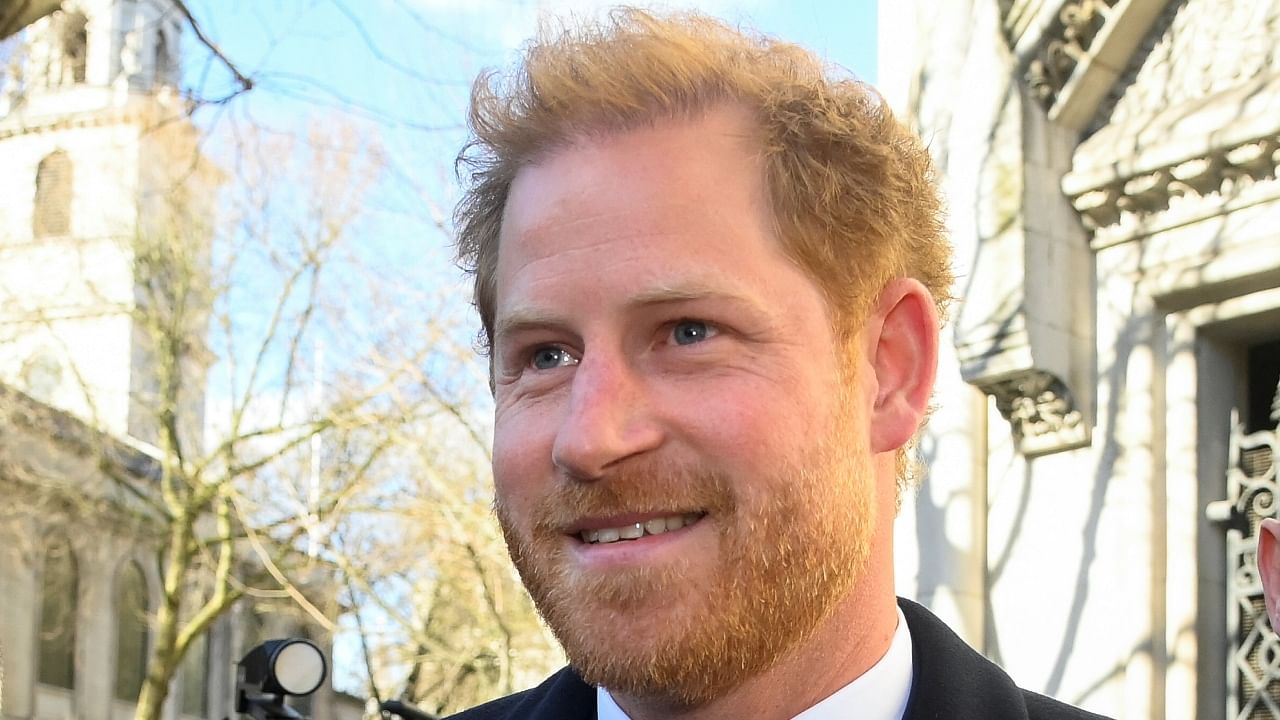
[0,4,562,720]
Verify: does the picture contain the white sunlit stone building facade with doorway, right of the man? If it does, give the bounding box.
[879,0,1280,720]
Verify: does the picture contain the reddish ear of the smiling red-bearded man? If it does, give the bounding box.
[863,278,938,452]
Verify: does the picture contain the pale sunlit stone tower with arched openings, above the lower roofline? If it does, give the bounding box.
[0,0,216,441]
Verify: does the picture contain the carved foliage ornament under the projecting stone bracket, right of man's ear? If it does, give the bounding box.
[983,370,1089,457]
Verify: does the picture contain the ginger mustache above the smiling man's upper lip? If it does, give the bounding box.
[517,460,737,536]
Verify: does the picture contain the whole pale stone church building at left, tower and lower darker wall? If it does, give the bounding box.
[0,0,362,720]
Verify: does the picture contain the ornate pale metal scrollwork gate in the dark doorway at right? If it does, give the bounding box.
[1207,407,1280,720]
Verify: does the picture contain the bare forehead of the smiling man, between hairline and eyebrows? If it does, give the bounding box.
[495,108,777,288]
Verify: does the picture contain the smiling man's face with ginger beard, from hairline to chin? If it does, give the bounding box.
[493,110,874,705]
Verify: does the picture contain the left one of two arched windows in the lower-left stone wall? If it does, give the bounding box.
[37,541,79,688]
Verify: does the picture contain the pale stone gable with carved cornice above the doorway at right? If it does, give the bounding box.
[1062,0,1280,247]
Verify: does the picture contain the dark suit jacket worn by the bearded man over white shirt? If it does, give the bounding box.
[453,598,1106,720]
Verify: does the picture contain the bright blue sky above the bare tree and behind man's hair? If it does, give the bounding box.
[184,0,876,313]
